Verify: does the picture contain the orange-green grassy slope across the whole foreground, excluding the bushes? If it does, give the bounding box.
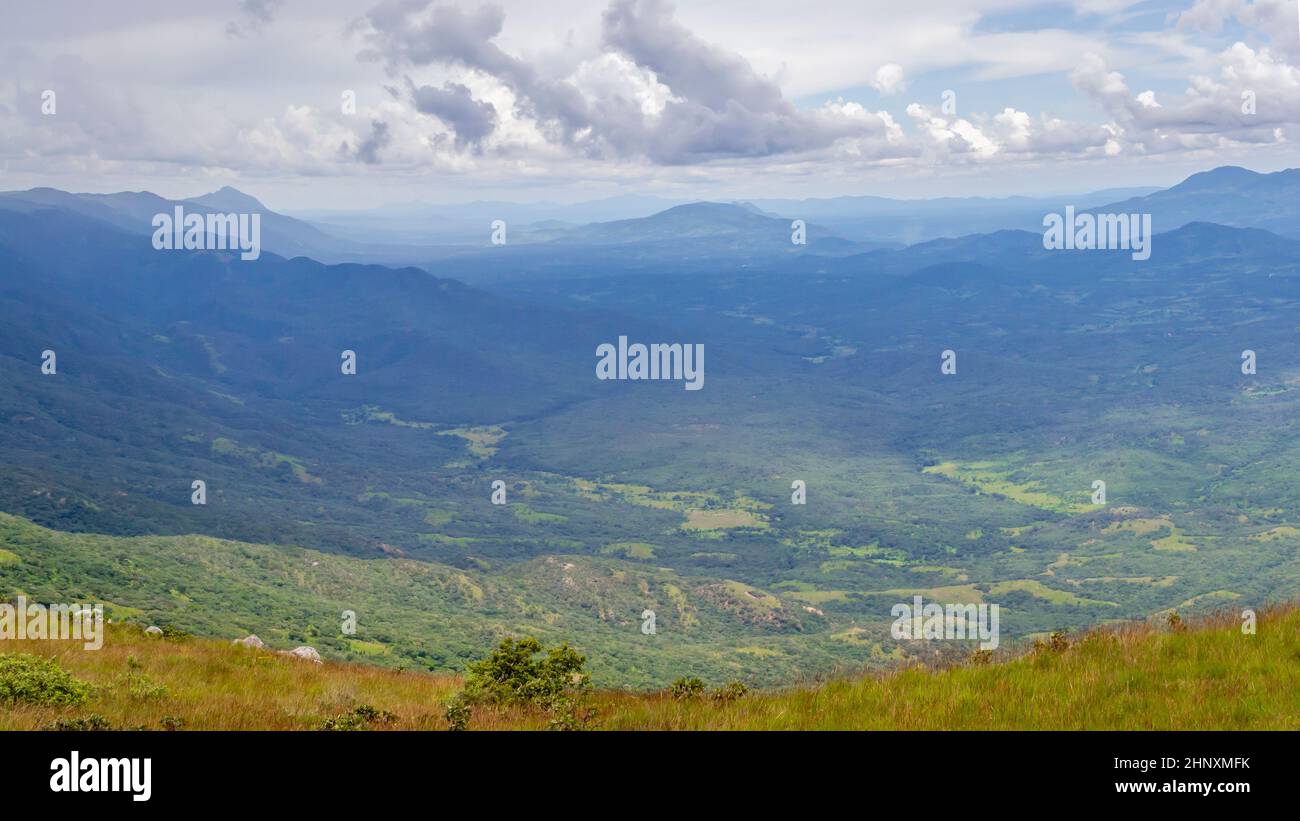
[0,605,1300,730]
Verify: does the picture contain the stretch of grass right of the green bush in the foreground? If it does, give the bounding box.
[590,607,1300,730]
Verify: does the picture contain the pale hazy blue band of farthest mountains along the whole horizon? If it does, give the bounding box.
[10,168,1300,282]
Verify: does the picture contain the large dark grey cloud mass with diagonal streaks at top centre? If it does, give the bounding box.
[361,0,884,165]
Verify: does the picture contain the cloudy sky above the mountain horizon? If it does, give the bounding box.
[0,0,1300,210]
